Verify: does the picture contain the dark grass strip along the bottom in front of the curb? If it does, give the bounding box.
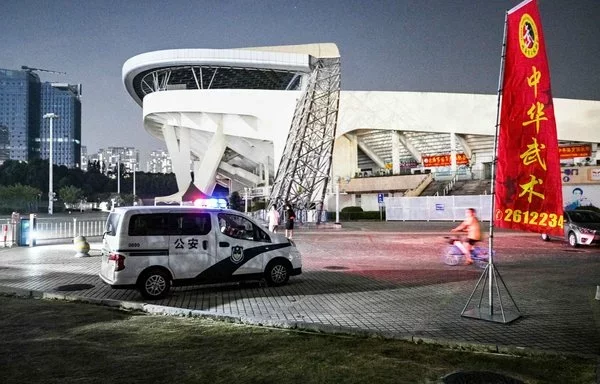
[0,296,597,384]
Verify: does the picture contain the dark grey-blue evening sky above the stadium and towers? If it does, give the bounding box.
[0,0,600,164]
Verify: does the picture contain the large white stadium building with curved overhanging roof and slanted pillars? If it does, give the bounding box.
[123,43,600,210]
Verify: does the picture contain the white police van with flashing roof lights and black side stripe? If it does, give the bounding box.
[100,206,302,299]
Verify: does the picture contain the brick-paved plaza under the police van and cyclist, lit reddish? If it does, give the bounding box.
[0,222,600,356]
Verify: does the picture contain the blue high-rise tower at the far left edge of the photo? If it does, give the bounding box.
[0,69,42,161]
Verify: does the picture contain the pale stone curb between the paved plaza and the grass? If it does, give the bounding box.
[0,285,599,359]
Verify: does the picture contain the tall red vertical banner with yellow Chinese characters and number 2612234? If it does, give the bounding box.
[494,0,563,235]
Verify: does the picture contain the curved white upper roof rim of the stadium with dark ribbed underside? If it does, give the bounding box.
[122,47,310,105]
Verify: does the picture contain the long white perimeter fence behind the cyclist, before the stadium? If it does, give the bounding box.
[384,195,492,221]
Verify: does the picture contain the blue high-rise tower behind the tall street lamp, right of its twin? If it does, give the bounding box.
[40,83,81,168]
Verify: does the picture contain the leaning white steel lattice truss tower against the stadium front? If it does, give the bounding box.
[269,58,340,223]
